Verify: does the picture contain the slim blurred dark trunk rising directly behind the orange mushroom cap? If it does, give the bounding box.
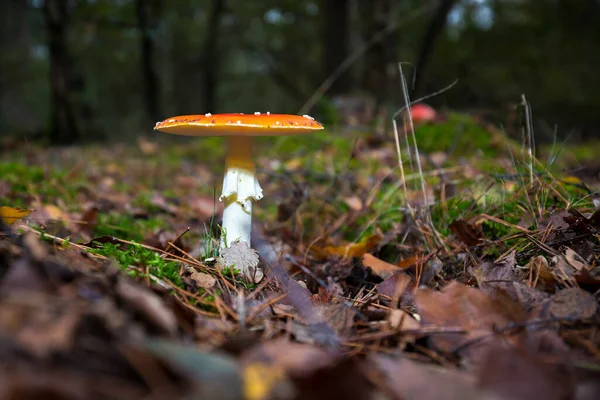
[203,0,225,112]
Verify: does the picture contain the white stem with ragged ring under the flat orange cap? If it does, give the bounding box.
[219,136,263,248]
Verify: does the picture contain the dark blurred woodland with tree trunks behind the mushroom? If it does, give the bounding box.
[0,0,600,144]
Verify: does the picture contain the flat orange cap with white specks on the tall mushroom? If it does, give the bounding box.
[154,112,323,136]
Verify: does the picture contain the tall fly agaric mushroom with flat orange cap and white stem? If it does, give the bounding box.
[154,112,323,252]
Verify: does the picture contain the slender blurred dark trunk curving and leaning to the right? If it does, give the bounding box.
[413,0,456,98]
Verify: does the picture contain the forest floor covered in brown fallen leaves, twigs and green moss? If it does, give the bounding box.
[0,114,600,400]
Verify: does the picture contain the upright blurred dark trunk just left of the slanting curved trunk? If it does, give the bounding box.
[360,0,398,109]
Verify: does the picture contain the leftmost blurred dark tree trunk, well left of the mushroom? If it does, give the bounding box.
[43,0,79,144]
